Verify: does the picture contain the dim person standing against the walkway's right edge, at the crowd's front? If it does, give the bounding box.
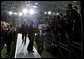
[36,29,44,55]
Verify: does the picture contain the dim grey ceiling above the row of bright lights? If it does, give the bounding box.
[1,1,79,12]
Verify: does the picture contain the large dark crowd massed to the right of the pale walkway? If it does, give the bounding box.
[36,4,81,57]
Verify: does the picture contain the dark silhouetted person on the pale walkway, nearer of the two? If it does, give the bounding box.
[27,21,34,53]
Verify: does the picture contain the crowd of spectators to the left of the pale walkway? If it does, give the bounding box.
[1,21,17,56]
